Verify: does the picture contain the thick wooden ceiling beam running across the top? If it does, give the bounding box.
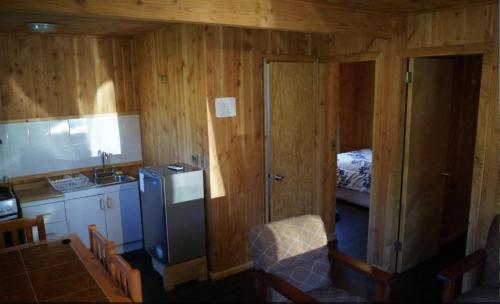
[0,0,391,38]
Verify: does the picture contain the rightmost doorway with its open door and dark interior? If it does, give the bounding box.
[396,55,482,273]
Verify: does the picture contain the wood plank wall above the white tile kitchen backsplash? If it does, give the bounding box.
[0,34,139,121]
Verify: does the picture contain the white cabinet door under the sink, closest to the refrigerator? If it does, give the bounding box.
[106,189,142,245]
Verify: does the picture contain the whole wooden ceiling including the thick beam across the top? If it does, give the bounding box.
[0,0,495,38]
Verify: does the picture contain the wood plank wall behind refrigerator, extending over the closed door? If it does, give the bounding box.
[134,24,394,273]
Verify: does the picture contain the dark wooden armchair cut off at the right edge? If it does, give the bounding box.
[437,215,500,303]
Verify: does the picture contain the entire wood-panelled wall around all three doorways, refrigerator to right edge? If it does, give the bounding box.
[133,1,500,273]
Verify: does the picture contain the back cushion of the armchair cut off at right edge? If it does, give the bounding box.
[481,214,500,288]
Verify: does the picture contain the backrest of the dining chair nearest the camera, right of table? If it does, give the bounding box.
[110,255,142,302]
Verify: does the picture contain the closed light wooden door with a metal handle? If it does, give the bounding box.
[268,62,318,221]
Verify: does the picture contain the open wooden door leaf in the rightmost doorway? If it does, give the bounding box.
[397,58,453,272]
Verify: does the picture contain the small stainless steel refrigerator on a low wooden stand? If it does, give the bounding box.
[139,164,206,265]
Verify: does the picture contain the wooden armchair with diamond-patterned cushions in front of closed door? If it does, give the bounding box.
[250,215,394,303]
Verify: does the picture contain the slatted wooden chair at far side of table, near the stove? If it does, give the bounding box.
[0,215,47,248]
